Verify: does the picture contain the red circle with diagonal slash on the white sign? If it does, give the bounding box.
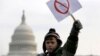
[54,0,70,14]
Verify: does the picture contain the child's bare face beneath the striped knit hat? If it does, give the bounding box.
[45,37,57,53]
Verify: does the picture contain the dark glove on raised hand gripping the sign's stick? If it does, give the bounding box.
[70,20,83,36]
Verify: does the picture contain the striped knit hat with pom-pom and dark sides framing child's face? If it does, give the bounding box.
[43,28,62,53]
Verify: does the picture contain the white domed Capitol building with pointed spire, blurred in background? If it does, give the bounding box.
[6,11,37,56]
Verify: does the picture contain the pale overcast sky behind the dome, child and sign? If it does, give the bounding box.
[0,0,100,55]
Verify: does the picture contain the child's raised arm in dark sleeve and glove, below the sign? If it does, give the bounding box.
[63,20,82,56]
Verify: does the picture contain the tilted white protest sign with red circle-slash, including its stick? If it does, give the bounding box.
[47,0,81,21]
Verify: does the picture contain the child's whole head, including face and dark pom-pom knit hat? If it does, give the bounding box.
[43,28,62,53]
